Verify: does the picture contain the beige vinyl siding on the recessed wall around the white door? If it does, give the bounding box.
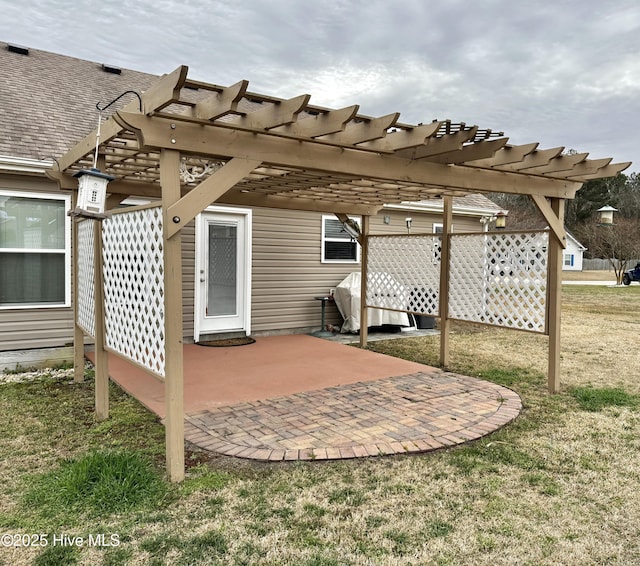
[183,208,480,340]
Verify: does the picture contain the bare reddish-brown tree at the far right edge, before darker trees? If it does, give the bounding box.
[575,218,640,285]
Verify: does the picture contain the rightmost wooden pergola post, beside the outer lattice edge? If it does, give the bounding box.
[547,198,565,393]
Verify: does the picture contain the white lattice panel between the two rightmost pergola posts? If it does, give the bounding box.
[449,232,549,332]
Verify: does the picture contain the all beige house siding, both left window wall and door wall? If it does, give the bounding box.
[0,180,490,351]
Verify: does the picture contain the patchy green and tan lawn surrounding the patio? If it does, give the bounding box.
[0,285,640,566]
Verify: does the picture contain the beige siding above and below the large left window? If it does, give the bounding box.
[0,175,73,351]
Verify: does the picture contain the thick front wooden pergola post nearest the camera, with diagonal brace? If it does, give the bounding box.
[160,149,184,482]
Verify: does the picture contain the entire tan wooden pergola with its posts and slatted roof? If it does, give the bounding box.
[50,66,629,481]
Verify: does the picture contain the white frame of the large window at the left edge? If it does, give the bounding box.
[0,188,71,311]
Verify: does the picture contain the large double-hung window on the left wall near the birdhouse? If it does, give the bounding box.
[0,190,71,308]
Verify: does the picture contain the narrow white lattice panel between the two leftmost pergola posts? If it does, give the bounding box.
[76,220,97,338]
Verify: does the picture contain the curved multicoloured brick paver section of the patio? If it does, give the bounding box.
[185,370,522,462]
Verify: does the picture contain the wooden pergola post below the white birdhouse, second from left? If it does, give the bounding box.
[92,220,109,421]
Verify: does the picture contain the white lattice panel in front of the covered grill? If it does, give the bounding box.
[367,235,441,316]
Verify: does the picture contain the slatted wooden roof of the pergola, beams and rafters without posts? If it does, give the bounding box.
[51,67,628,211]
